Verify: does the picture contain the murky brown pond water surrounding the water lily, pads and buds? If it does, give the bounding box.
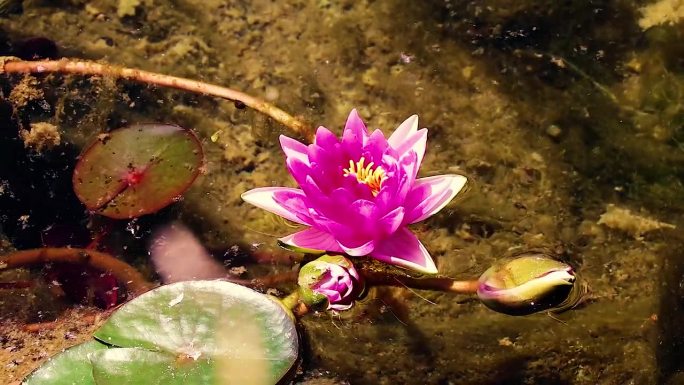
[0,0,684,385]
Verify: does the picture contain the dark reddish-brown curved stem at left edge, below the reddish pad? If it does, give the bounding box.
[0,247,154,295]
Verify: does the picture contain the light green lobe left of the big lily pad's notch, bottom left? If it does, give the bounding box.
[22,341,107,385]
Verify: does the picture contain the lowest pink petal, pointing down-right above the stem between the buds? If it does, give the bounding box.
[370,227,437,274]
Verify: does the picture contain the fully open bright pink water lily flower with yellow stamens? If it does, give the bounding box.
[242,110,466,273]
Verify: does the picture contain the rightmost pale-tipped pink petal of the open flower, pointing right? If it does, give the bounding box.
[404,174,467,224]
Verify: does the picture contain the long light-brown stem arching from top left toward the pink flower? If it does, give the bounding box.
[0,57,311,138]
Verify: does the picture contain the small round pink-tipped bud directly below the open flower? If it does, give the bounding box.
[297,254,363,311]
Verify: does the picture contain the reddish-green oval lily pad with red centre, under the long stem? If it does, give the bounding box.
[73,124,204,219]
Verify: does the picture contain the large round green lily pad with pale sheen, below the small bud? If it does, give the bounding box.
[94,281,298,385]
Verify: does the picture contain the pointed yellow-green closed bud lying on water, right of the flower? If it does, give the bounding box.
[477,253,587,315]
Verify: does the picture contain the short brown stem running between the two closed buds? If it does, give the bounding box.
[362,271,478,294]
